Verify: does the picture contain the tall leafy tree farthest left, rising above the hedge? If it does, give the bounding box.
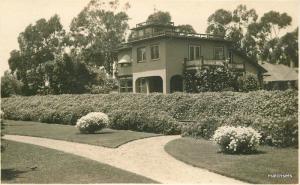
[8,15,65,95]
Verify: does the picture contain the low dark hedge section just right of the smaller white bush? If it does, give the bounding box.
[109,110,180,134]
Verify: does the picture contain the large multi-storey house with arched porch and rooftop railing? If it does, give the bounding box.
[116,22,263,93]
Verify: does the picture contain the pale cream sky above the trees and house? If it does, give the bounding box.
[0,0,300,76]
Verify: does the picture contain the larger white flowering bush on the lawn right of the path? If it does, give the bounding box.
[212,126,261,153]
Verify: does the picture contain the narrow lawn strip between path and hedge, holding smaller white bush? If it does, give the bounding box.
[3,120,158,148]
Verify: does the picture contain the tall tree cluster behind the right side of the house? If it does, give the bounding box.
[206,4,298,66]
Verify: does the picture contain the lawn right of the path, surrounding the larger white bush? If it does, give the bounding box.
[165,138,298,184]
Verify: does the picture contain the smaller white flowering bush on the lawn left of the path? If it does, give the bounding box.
[75,112,109,133]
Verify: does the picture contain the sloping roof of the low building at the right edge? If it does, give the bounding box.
[261,62,298,82]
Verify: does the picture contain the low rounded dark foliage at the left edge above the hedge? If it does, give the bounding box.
[1,71,23,97]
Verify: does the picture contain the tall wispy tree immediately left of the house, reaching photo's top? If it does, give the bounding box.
[68,0,129,74]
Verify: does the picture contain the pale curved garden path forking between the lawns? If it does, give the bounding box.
[3,135,244,184]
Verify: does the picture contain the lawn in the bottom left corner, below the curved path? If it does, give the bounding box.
[1,140,155,184]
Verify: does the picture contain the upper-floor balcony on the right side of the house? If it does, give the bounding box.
[185,59,245,70]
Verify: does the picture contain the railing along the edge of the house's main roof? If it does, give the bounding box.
[128,31,224,42]
